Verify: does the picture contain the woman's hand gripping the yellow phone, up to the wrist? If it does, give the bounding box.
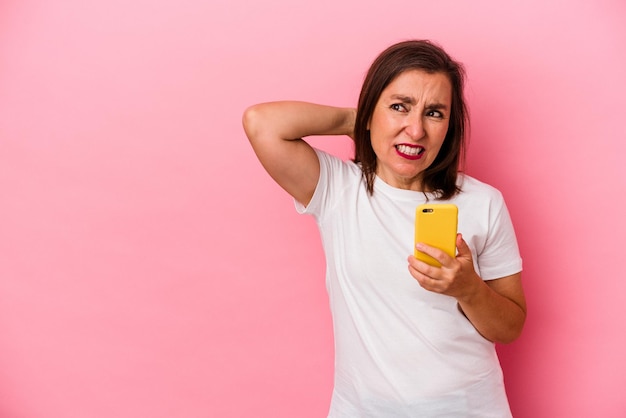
[408,234,484,301]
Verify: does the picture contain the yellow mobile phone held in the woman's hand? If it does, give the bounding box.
[415,203,459,267]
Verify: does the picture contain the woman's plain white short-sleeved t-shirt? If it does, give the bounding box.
[296,150,522,418]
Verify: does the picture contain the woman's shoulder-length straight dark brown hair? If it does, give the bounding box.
[354,40,469,199]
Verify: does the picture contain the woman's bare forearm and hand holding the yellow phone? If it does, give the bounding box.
[409,234,526,343]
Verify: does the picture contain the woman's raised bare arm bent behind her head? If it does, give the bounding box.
[243,102,355,205]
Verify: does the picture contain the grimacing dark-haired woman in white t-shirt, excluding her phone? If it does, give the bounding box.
[244,41,526,418]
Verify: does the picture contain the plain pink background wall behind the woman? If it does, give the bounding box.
[0,0,626,418]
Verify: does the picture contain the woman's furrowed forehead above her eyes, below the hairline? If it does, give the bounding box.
[380,70,452,104]
